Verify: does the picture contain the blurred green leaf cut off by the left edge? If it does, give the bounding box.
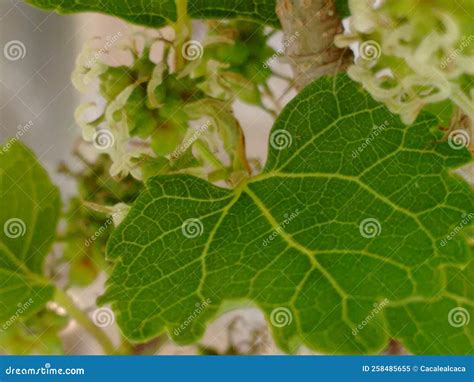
[0,140,60,330]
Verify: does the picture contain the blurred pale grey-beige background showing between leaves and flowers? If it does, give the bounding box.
[0,0,298,354]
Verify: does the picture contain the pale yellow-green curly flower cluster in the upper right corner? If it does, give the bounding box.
[336,0,474,124]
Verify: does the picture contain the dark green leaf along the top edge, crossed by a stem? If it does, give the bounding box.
[26,0,279,28]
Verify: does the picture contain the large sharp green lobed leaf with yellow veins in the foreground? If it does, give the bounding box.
[102,74,474,354]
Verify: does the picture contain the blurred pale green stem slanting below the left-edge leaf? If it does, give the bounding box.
[54,288,116,354]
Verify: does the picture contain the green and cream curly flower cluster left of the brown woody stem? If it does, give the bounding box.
[73,22,273,179]
